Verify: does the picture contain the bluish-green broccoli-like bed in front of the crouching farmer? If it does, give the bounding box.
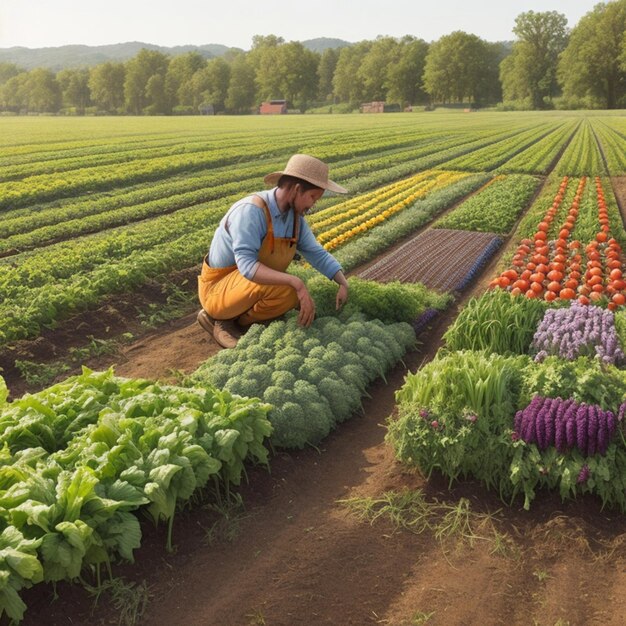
[191,314,415,448]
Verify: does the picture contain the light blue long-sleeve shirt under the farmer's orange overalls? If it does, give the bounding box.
[209,187,341,280]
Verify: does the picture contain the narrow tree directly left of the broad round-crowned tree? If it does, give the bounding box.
[387,37,428,106]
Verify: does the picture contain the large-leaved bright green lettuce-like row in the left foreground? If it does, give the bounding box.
[0,370,272,620]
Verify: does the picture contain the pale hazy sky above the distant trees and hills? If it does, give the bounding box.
[0,0,597,50]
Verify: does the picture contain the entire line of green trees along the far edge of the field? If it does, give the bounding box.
[0,0,626,115]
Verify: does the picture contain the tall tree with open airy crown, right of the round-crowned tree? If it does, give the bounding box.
[500,11,567,109]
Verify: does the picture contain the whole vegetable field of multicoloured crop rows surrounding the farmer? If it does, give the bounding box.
[0,113,626,623]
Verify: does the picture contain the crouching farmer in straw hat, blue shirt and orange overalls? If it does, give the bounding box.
[198,154,348,348]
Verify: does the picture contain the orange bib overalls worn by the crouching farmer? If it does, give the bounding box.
[198,195,299,326]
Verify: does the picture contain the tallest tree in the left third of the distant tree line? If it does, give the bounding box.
[124,48,169,115]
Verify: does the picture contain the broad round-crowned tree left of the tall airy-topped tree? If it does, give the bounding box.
[424,31,492,103]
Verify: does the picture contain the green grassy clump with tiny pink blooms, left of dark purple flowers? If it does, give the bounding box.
[387,351,529,493]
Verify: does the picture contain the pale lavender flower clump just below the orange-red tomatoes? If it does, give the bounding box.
[530,301,624,365]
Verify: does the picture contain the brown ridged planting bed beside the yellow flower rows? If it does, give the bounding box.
[358,229,502,291]
